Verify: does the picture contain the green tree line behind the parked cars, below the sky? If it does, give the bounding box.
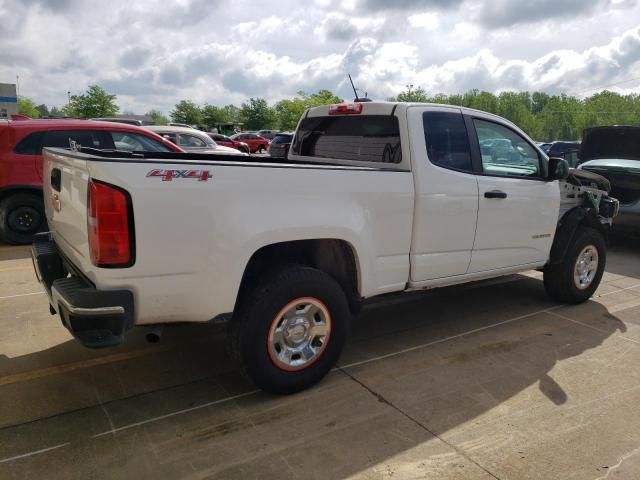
[18,85,640,141]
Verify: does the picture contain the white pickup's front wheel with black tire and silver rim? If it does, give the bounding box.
[544,226,607,303]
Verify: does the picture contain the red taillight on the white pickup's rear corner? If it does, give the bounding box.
[87,180,134,267]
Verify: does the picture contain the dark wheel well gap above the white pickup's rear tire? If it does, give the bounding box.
[234,238,362,314]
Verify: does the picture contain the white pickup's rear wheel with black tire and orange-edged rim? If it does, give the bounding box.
[229,265,351,394]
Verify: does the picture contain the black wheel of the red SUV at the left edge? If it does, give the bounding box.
[0,193,47,245]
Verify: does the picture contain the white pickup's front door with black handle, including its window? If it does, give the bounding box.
[467,117,560,273]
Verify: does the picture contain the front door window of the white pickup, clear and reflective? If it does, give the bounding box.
[473,118,541,178]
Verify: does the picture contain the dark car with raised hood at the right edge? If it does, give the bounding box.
[578,126,640,228]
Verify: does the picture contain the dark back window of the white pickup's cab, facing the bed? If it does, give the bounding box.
[292,115,402,163]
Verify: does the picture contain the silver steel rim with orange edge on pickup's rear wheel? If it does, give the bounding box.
[267,297,331,371]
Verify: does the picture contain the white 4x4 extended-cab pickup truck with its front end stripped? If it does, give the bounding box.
[32,102,618,393]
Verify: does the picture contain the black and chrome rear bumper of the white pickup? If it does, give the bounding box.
[31,233,133,348]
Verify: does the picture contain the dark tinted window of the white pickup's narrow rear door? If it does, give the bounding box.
[422,112,472,172]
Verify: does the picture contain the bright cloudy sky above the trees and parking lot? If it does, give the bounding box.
[0,0,640,113]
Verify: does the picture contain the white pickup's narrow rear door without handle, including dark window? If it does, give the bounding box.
[407,107,478,282]
